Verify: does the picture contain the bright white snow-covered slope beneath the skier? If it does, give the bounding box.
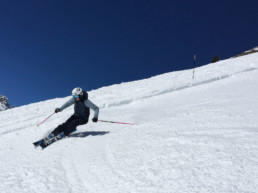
[0,53,258,193]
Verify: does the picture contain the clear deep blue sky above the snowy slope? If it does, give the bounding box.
[0,0,258,106]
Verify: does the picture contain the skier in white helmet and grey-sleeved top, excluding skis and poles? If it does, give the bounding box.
[50,87,99,137]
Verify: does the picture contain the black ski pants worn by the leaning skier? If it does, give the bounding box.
[51,115,88,136]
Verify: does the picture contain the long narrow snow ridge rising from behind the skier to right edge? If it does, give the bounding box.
[100,67,258,108]
